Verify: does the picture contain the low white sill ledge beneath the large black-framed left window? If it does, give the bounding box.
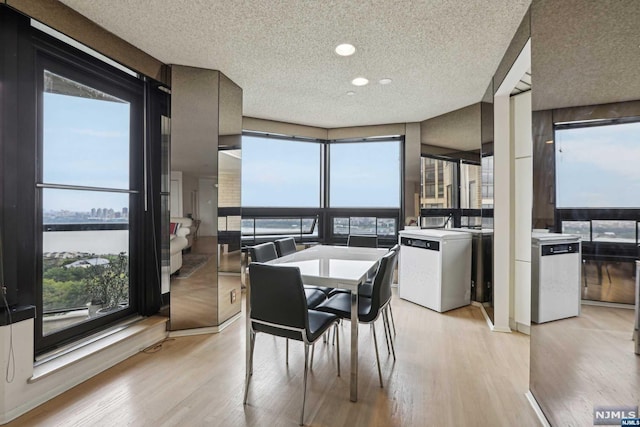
[27,316,168,384]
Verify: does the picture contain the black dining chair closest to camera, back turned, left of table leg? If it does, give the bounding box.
[244,263,340,425]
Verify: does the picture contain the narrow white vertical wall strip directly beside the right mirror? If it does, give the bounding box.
[509,92,533,333]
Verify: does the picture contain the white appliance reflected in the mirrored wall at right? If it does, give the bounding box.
[531,233,582,323]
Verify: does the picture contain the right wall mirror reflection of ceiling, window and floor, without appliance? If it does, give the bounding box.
[530,1,640,418]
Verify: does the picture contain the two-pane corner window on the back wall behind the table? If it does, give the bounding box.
[242,133,402,244]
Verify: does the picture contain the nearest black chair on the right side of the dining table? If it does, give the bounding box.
[316,251,398,387]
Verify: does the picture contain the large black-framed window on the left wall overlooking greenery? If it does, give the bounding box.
[0,7,167,357]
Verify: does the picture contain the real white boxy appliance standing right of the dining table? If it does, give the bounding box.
[398,229,471,313]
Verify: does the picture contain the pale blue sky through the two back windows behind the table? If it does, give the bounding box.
[242,137,400,208]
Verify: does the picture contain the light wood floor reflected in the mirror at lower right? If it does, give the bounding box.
[531,304,640,427]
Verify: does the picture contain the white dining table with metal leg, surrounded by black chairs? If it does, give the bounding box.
[254,245,388,402]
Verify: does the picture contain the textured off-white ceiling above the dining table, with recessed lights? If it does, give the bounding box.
[62,0,530,128]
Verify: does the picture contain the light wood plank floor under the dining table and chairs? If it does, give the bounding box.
[8,296,539,427]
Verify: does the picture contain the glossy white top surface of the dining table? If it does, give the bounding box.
[267,245,388,291]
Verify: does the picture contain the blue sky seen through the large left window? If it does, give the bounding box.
[42,93,130,212]
